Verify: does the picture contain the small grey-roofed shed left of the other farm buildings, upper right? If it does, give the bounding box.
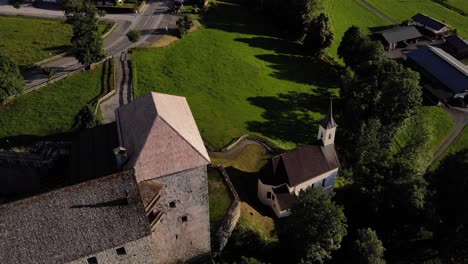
[375,26,422,50]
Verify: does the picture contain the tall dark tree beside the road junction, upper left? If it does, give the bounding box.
[71,3,105,67]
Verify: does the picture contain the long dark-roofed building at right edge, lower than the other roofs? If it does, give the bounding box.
[404,45,468,100]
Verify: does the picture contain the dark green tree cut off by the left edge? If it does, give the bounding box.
[0,50,24,102]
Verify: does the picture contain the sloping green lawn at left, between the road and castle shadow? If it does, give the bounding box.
[0,64,102,138]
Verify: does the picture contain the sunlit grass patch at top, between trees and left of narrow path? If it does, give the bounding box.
[324,0,390,58]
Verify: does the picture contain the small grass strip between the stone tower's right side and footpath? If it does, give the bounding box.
[208,168,233,234]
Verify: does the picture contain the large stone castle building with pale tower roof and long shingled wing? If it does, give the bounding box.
[0,93,211,264]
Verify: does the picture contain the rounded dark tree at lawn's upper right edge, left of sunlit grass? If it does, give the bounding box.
[304,13,333,57]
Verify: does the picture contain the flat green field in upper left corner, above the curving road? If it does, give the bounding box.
[0,16,108,68]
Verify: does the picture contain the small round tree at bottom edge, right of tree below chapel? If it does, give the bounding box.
[354,228,385,264]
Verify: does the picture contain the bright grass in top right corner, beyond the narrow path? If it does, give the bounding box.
[367,0,468,38]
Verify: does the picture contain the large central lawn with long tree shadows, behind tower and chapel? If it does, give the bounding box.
[132,0,338,148]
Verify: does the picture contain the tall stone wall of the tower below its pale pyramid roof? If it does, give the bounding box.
[147,166,211,263]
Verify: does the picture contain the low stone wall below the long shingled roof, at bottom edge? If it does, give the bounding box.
[69,236,155,264]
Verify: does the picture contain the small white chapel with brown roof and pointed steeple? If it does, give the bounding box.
[257,103,340,217]
